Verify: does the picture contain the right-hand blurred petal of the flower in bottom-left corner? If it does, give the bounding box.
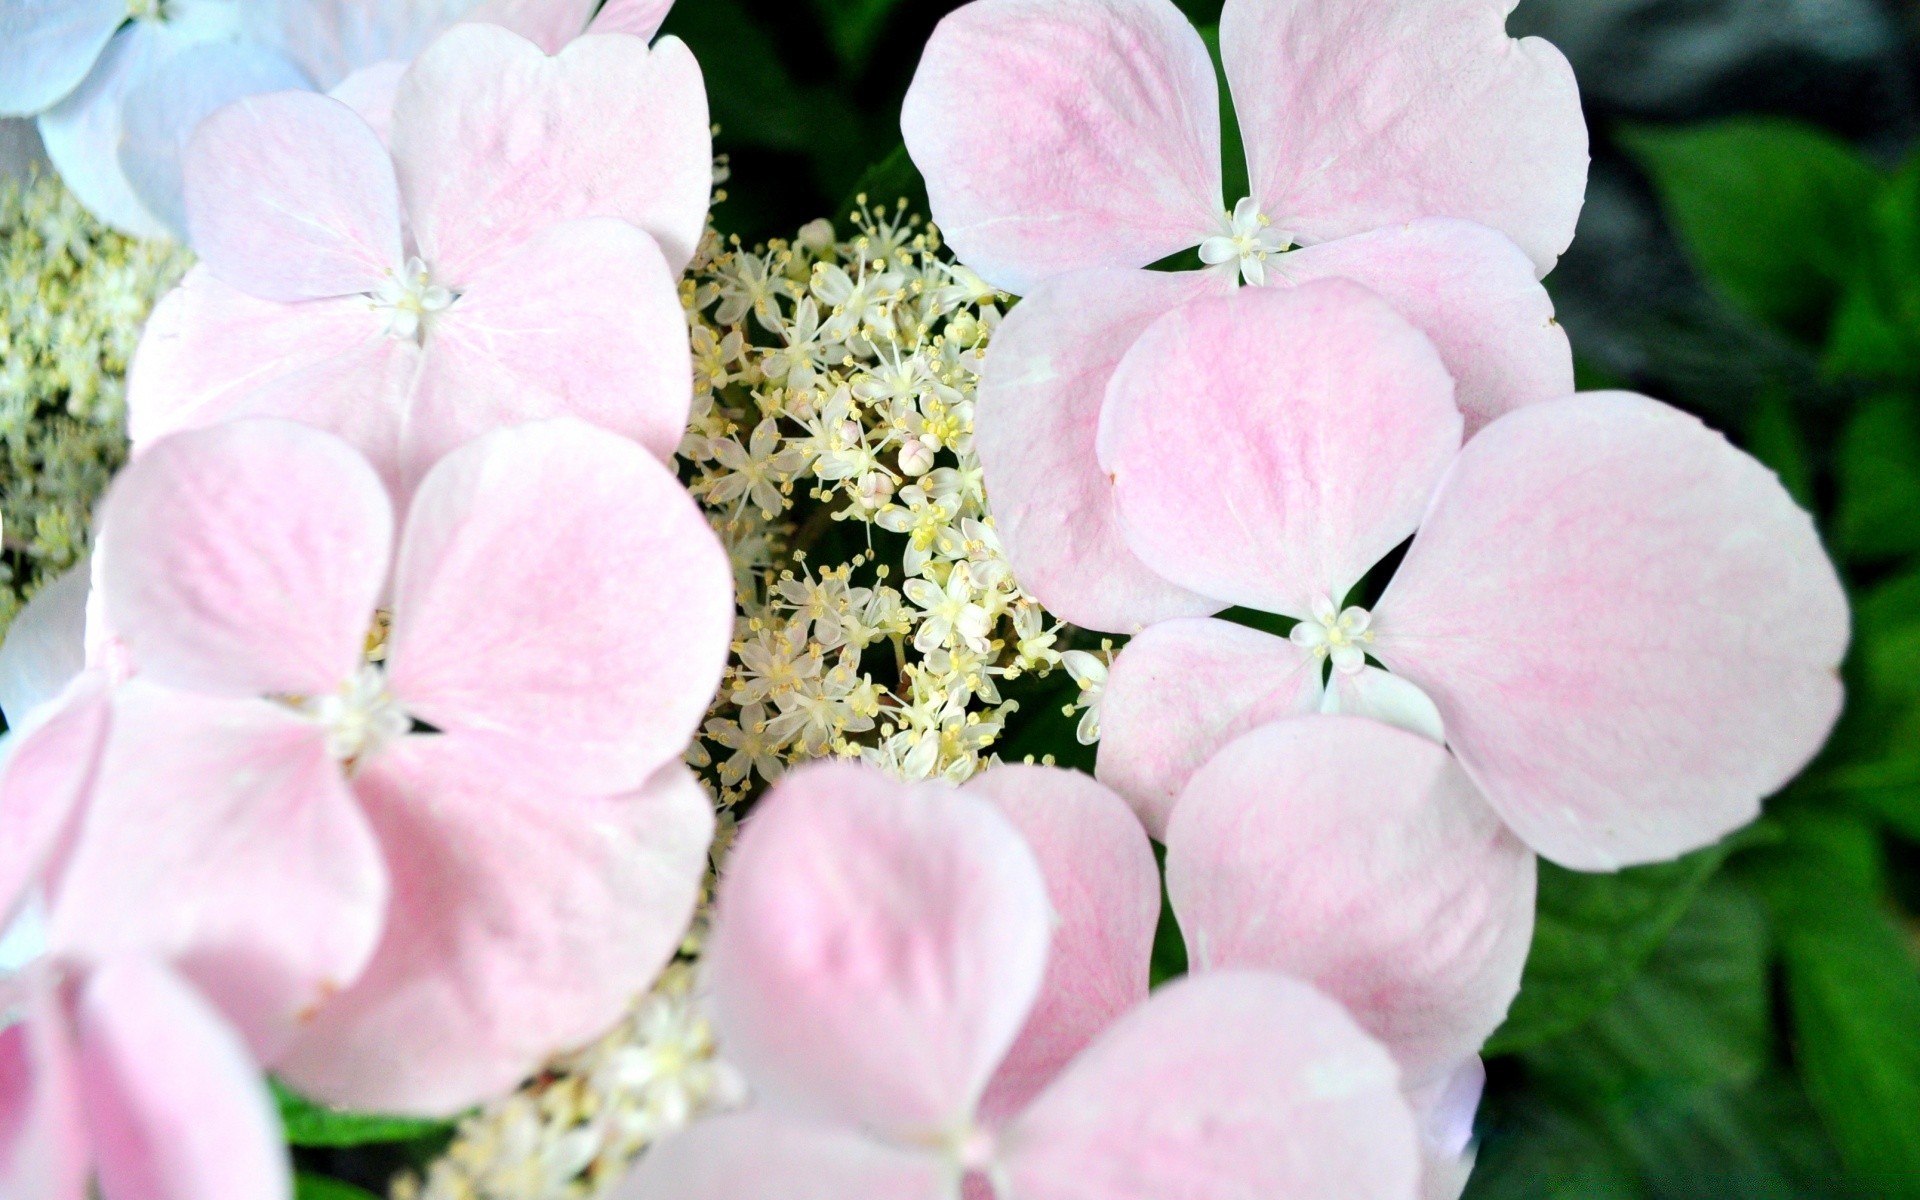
[77,958,294,1200]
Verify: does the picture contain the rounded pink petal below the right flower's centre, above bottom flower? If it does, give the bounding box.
[1167,716,1534,1087]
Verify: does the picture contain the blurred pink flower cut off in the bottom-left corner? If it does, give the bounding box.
[0,958,294,1200]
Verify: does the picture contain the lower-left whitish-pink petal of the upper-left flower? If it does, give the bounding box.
[127,267,420,478]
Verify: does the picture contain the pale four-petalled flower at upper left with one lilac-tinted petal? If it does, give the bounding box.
[129,23,712,490]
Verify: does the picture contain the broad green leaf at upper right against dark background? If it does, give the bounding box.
[1619,117,1882,340]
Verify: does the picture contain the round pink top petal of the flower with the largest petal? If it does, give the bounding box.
[1098,278,1461,616]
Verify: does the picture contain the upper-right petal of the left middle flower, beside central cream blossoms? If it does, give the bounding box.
[388,420,733,793]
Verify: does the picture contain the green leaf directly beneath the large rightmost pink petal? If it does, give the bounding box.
[1486,841,1736,1054]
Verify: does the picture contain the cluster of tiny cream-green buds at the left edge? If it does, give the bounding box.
[0,175,190,632]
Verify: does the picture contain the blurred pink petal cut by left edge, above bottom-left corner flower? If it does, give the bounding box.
[0,672,111,927]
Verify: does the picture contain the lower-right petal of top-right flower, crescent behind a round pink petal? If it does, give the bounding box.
[1267,221,1572,438]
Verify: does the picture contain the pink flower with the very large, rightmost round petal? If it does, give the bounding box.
[1098,280,1849,870]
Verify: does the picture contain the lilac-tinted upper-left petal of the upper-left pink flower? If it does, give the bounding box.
[186,92,401,301]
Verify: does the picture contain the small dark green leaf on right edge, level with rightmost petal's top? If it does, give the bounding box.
[1834,396,1920,559]
